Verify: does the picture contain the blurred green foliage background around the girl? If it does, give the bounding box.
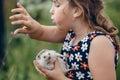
[0,0,120,80]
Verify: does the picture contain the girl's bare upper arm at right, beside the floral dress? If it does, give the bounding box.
[88,36,116,80]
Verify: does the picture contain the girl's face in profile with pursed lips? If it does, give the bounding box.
[50,0,73,29]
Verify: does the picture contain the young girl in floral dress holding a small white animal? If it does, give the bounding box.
[10,0,119,80]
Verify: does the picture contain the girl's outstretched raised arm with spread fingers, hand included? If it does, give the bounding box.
[10,3,67,42]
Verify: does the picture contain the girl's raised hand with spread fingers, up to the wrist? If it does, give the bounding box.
[9,3,40,34]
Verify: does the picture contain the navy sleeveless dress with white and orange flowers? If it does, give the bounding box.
[61,30,118,80]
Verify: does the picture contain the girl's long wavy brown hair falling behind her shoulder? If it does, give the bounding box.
[69,0,120,52]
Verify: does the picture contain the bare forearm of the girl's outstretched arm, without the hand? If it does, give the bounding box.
[29,25,68,42]
